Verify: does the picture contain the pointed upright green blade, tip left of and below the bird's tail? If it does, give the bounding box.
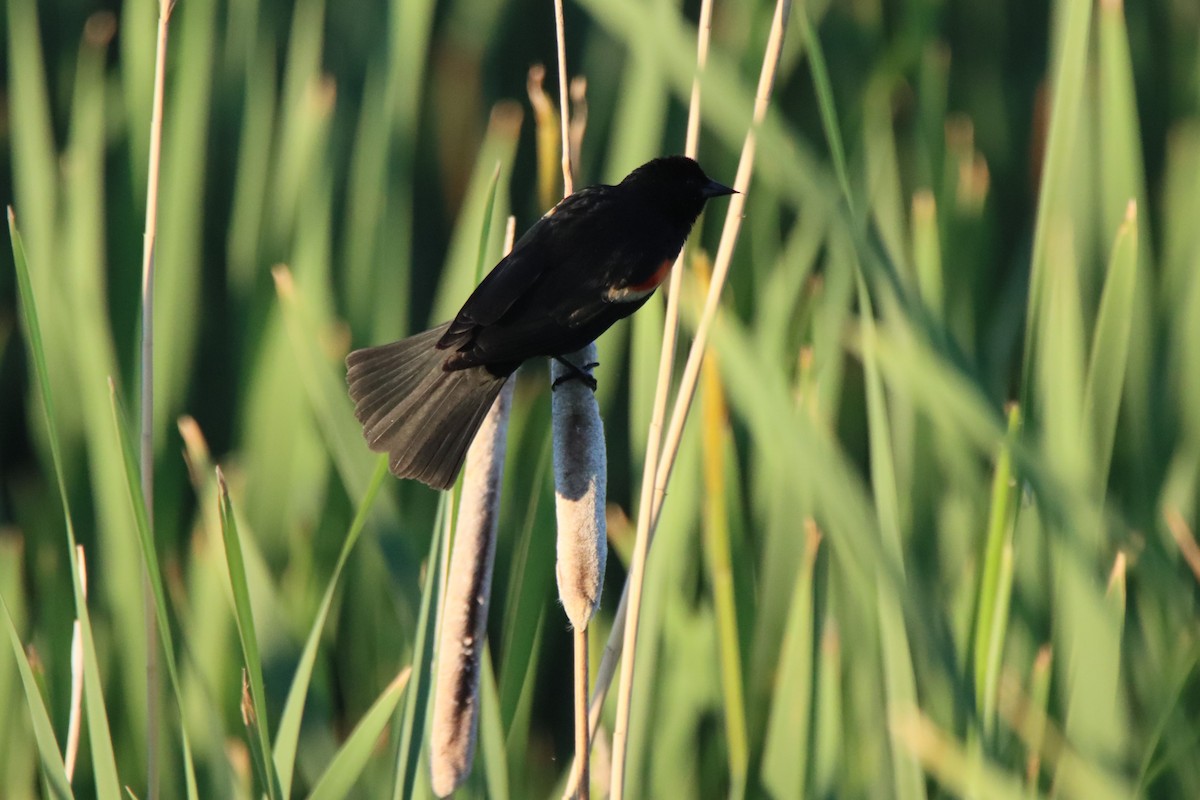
[217,467,283,800]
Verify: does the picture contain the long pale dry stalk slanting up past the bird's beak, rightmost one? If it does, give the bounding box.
[612,0,791,800]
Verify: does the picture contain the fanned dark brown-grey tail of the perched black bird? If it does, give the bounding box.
[346,323,506,489]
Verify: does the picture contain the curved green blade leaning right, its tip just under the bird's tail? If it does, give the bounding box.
[275,457,388,796]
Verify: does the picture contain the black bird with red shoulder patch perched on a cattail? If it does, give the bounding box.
[346,156,733,489]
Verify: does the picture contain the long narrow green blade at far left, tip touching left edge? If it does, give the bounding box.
[8,206,121,800]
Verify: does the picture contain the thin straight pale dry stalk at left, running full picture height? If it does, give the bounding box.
[139,0,174,800]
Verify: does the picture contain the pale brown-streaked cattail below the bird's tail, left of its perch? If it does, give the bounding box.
[430,217,516,798]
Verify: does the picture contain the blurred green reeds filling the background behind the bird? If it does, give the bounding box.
[0,0,1200,798]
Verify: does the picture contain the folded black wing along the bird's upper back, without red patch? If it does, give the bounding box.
[438,186,612,349]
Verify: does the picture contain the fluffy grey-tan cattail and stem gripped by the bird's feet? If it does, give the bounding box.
[550,0,607,800]
